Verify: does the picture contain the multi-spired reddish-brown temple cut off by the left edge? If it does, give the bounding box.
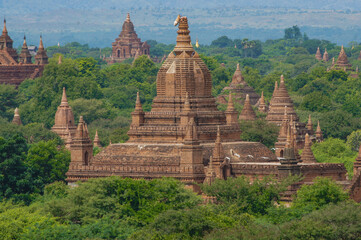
[0,20,48,86]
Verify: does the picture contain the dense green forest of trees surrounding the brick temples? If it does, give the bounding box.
[0,26,361,239]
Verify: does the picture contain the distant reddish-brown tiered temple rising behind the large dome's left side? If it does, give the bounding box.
[106,13,150,63]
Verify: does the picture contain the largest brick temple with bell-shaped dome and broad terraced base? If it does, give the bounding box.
[67,17,277,188]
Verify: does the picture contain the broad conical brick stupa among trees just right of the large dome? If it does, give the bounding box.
[217,64,260,105]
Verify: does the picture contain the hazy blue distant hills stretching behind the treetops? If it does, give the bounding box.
[0,0,361,47]
